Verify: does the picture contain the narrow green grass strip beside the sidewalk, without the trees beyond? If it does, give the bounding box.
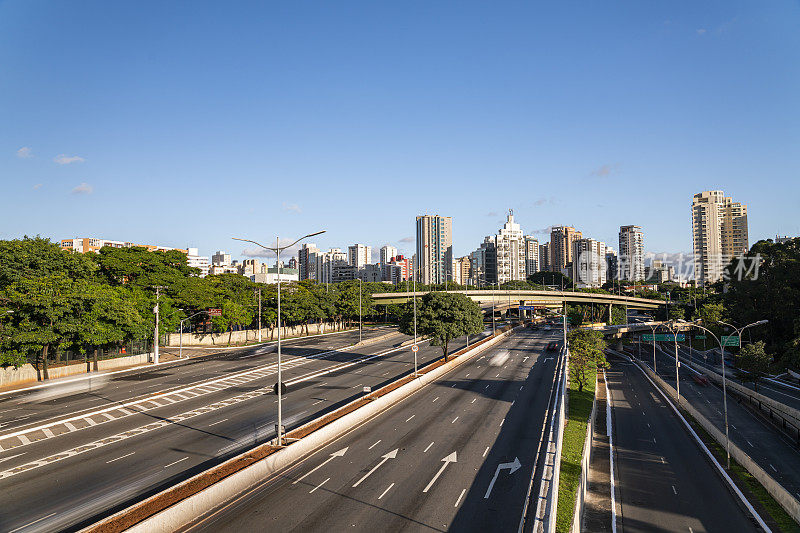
[556,369,597,533]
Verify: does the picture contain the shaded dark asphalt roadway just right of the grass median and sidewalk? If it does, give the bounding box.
[606,355,758,532]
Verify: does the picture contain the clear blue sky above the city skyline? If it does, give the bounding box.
[0,0,800,262]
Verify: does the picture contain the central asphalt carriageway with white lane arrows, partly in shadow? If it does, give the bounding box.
[188,330,559,531]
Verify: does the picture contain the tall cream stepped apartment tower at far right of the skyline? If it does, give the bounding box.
[692,191,749,285]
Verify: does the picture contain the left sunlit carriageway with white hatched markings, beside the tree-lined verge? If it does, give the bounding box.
[0,330,488,531]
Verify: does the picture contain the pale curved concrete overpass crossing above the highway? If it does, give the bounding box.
[372,290,667,309]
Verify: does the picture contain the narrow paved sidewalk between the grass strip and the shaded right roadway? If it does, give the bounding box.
[581,373,611,532]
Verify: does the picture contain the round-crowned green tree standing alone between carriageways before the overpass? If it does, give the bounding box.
[400,292,483,361]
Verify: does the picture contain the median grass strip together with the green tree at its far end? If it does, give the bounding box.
[556,330,606,533]
